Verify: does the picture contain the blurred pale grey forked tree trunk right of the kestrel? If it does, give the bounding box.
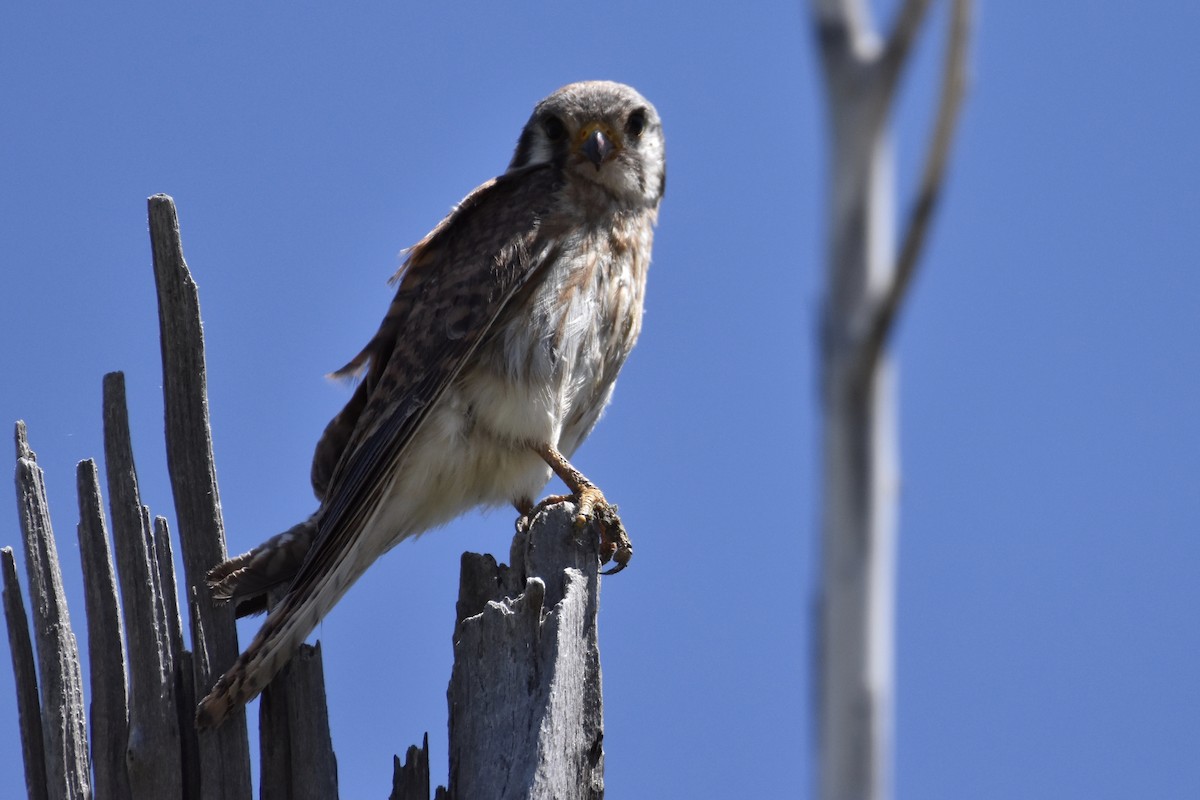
[811,0,971,800]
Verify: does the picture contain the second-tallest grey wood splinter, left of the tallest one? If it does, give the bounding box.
[103,372,184,798]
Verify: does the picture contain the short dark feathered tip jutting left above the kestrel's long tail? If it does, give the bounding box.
[206,515,317,616]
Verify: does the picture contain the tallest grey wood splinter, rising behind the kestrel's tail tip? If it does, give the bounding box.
[148,194,252,800]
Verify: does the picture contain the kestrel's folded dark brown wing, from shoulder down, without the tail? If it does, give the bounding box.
[297,166,560,597]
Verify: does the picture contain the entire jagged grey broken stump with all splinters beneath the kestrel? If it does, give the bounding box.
[2,196,619,800]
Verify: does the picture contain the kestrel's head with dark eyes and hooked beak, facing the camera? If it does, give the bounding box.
[509,80,666,207]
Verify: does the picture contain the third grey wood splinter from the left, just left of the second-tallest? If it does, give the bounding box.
[76,458,131,800]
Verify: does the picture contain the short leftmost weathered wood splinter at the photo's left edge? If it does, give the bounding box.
[0,547,50,800]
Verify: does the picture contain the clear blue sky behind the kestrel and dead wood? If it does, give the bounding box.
[0,1,1200,799]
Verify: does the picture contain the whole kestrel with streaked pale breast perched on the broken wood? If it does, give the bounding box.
[197,80,666,727]
